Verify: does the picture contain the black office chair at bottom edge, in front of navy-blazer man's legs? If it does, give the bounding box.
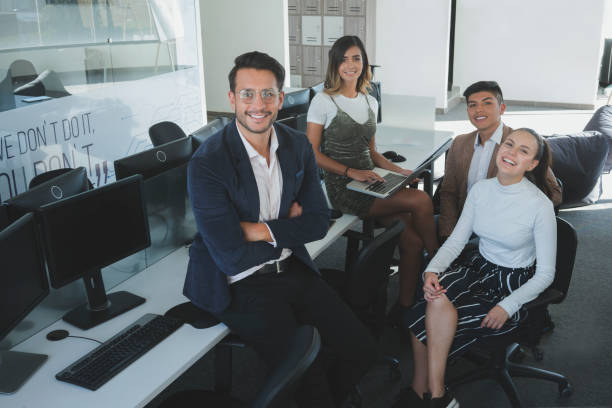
[160,326,321,408]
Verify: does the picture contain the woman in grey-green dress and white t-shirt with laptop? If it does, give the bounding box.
[306,36,438,307]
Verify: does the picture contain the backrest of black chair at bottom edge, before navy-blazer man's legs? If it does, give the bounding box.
[251,326,321,408]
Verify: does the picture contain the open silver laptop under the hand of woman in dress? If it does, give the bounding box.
[346,139,453,198]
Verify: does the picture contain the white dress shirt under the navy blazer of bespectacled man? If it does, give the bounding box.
[227,125,291,284]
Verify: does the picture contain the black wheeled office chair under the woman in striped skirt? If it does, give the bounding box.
[448,217,578,408]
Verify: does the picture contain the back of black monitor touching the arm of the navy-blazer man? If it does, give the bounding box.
[113,137,193,180]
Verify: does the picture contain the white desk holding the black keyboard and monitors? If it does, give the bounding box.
[0,215,357,408]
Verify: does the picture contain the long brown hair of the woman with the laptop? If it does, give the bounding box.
[324,35,372,95]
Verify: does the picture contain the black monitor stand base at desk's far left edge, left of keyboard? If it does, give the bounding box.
[0,351,48,394]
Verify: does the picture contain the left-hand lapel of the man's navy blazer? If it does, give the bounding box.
[225,120,259,222]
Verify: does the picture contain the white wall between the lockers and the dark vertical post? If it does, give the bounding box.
[374,0,452,109]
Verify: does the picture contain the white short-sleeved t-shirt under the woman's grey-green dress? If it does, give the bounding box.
[306,92,378,129]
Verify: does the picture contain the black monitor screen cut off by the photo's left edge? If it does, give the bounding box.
[0,213,49,340]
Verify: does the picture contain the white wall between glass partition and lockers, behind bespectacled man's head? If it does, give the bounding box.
[199,0,289,112]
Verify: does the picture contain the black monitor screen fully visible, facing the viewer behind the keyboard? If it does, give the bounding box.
[39,176,151,288]
